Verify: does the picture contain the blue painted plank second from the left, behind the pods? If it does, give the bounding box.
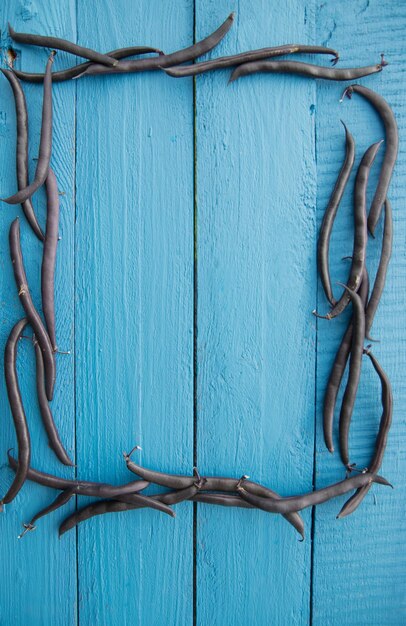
[75,0,193,626]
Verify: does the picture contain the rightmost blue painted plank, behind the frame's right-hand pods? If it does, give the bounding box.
[313,0,406,626]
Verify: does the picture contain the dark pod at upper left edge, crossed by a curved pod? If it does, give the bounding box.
[1,69,44,241]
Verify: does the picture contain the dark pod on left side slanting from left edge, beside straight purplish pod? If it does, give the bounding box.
[9,217,56,400]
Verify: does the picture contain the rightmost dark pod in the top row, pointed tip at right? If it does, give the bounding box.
[230,56,386,83]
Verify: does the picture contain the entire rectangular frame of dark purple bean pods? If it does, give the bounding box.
[1,14,398,538]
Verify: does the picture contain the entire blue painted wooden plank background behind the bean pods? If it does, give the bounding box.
[0,0,406,626]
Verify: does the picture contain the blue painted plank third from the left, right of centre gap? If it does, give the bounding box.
[196,0,316,625]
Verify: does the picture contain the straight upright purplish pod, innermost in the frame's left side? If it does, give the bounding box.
[41,168,59,352]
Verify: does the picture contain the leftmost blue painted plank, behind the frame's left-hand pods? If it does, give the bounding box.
[0,0,77,626]
